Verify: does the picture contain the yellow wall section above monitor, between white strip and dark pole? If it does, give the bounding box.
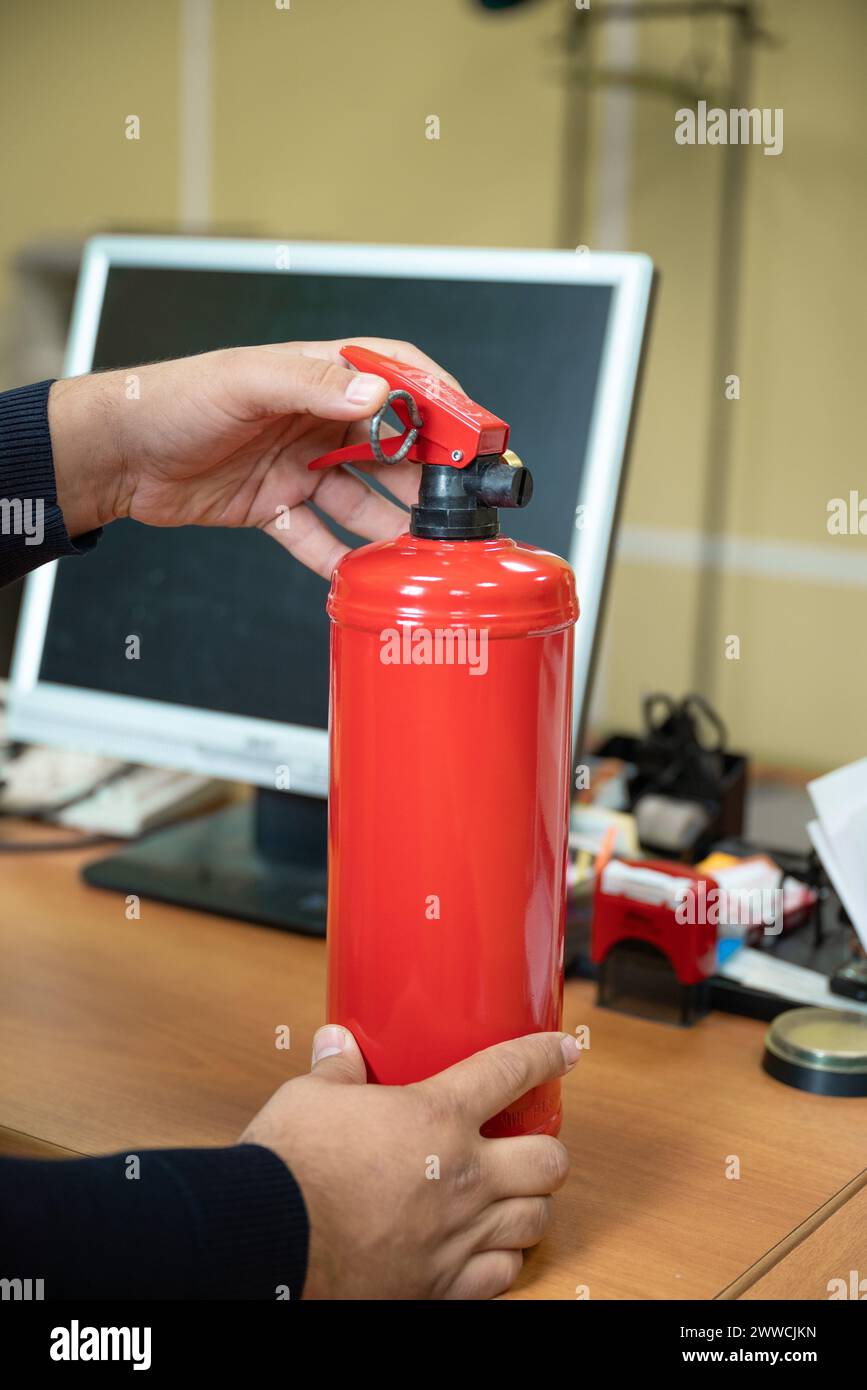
[214,0,561,246]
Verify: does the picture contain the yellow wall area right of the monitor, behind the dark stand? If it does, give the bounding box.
[604,0,867,769]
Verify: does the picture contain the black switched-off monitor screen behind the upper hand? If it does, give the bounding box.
[39,267,611,728]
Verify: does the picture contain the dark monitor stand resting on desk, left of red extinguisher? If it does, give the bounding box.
[82,788,328,937]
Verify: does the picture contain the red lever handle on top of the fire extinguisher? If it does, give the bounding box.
[307,345,509,468]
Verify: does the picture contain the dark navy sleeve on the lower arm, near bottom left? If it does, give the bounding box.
[0,1144,308,1300]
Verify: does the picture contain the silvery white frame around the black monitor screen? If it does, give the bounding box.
[8,236,653,795]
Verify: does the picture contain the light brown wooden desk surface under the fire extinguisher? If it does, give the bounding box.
[0,834,867,1300]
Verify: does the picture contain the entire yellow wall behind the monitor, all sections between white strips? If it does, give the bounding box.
[0,0,867,767]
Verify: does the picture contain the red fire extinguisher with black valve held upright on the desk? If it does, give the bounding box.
[310,346,578,1136]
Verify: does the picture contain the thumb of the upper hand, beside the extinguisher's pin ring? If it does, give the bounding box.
[226,348,389,420]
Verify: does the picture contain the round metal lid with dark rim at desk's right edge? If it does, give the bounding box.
[763,1008,867,1095]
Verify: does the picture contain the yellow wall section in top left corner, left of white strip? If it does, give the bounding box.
[0,0,178,282]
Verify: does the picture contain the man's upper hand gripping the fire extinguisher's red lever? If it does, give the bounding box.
[49,338,454,578]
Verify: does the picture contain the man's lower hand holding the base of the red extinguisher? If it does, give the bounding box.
[242,1024,579,1298]
